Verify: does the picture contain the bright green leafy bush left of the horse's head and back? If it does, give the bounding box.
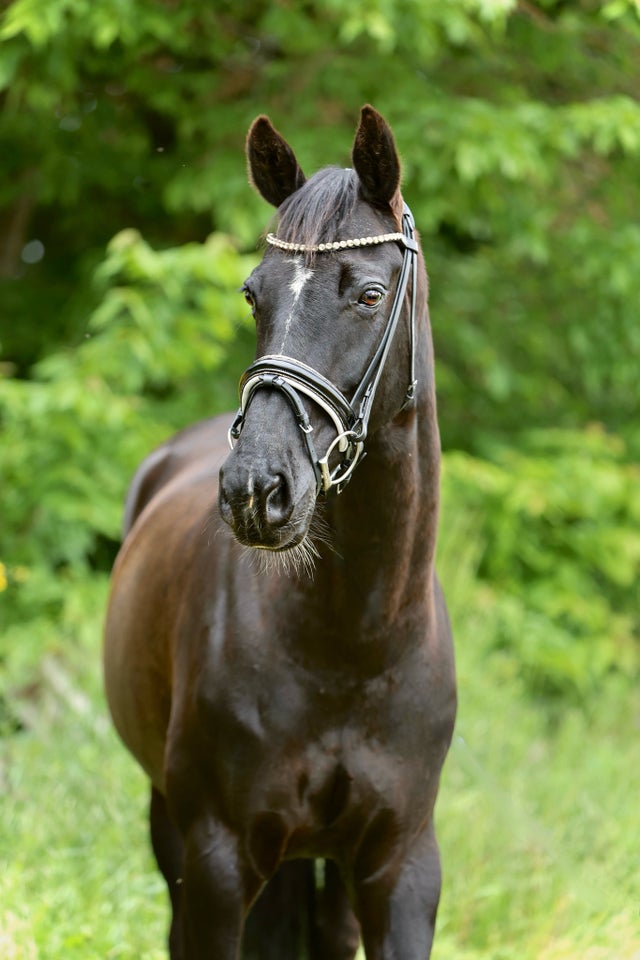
[0,231,254,691]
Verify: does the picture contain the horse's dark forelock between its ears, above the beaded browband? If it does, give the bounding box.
[278,167,359,251]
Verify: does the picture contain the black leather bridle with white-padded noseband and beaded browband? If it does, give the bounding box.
[229,203,418,496]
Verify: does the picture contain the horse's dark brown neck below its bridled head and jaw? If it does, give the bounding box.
[287,330,440,672]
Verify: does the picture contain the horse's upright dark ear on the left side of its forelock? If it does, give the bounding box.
[247,116,306,207]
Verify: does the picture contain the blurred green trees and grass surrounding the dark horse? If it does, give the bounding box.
[0,0,640,960]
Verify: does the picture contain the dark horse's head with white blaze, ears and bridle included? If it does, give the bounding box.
[219,106,418,551]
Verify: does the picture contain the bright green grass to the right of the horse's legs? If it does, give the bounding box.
[435,638,640,960]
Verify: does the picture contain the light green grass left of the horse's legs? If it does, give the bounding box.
[0,680,166,960]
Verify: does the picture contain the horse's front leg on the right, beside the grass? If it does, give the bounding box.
[356,823,441,960]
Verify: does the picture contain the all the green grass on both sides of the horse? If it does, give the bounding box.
[0,557,640,960]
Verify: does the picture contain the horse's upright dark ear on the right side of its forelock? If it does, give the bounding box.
[351,104,401,211]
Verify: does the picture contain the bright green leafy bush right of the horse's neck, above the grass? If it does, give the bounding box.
[443,428,640,704]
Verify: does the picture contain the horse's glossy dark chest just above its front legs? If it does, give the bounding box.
[188,663,429,873]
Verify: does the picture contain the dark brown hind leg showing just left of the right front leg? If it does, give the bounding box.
[310,860,360,960]
